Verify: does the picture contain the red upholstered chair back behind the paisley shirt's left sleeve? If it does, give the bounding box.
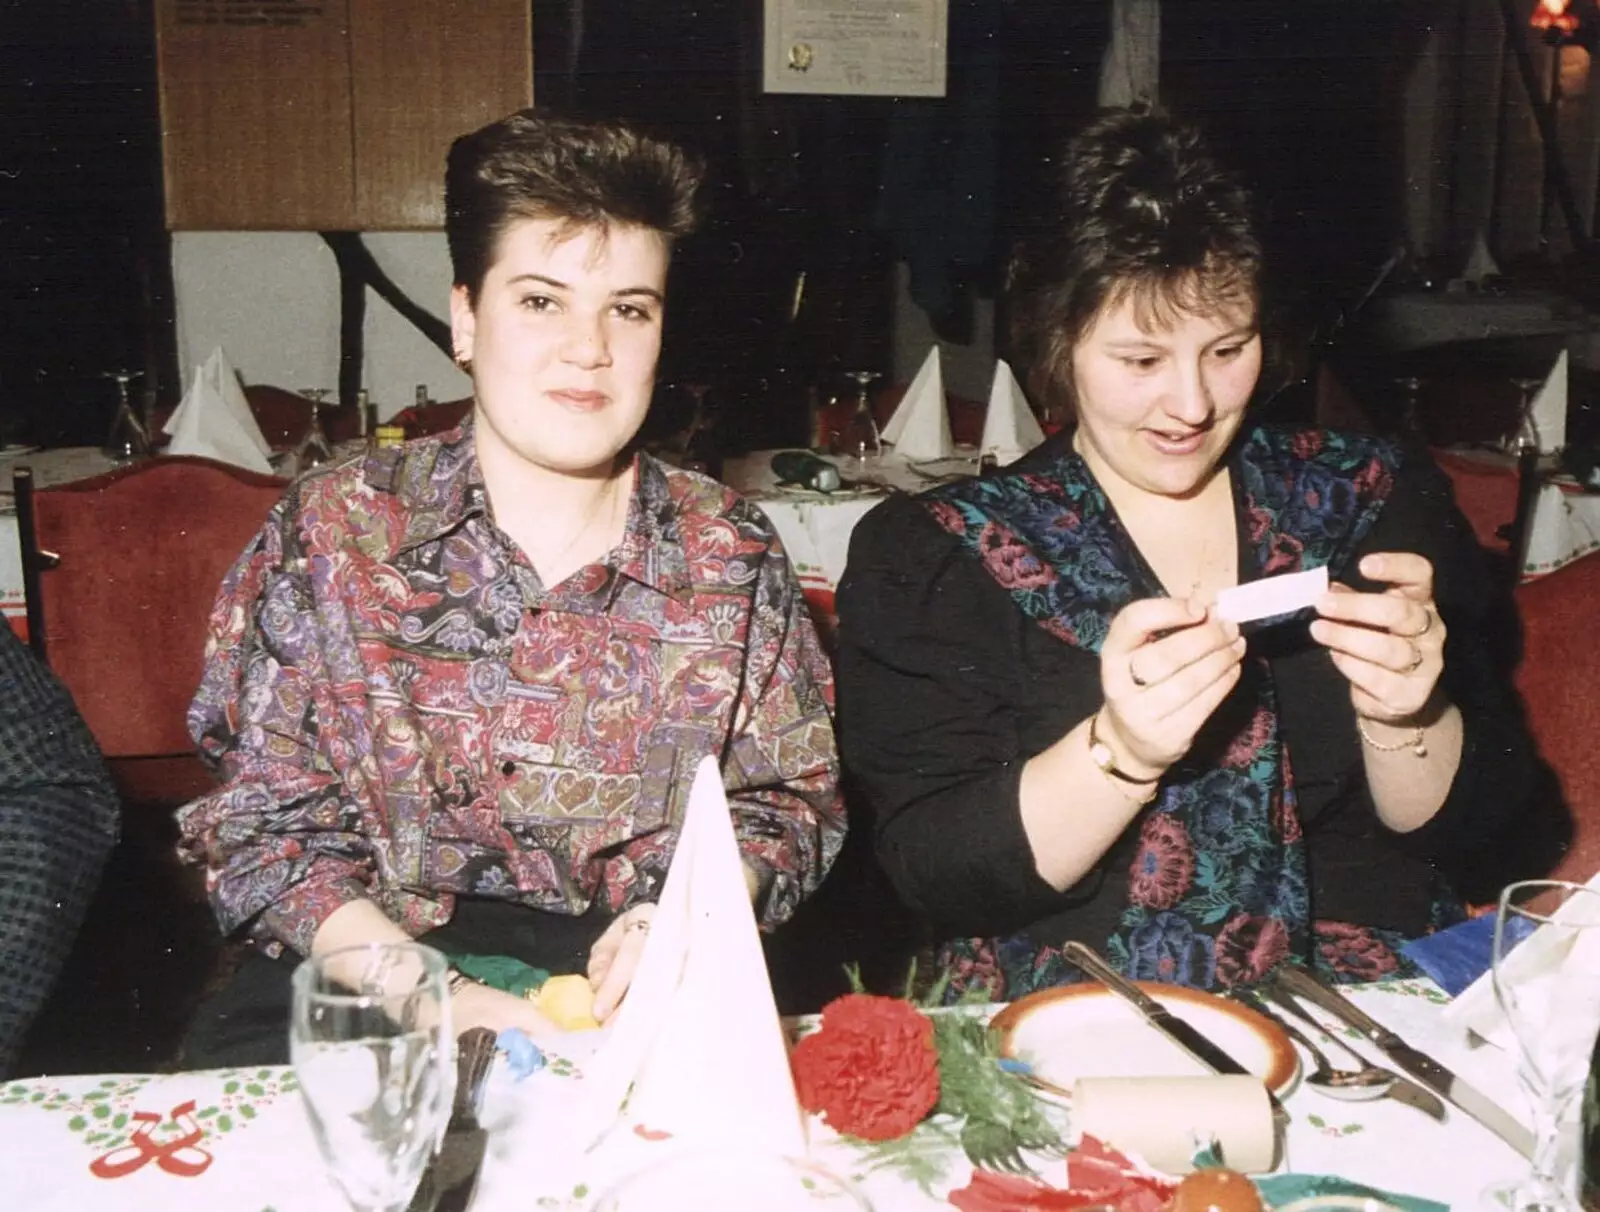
[14,456,286,803]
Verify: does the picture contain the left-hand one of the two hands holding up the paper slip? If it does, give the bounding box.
[1098,598,1245,779]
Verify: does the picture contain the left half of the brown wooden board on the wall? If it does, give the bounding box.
[155,0,355,230]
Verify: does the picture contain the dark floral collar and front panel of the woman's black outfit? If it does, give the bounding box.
[923,429,1398,998]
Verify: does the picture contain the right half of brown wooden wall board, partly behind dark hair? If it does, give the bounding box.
[349,0,533,230]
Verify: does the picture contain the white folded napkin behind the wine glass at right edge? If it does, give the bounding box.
[1445,875,1600,1051]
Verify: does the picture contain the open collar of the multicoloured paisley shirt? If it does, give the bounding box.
[374,416,693,598]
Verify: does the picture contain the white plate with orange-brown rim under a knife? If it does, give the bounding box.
[990,980,1299,1098]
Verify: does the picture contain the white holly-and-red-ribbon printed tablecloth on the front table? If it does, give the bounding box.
[0,982,1526,1212]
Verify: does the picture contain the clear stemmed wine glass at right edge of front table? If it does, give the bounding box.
[1491,879,1600,1212]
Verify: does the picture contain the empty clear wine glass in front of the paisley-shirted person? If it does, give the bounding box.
[290,943,456,1212]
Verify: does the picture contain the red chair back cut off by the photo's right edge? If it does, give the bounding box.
[1515,555,1600,879]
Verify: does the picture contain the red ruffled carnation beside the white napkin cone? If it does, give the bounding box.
[789,993,939,1140]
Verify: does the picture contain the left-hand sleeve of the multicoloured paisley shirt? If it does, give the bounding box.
[178,502,384,955]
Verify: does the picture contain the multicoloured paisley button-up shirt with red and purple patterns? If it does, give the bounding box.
[179,422,845,955]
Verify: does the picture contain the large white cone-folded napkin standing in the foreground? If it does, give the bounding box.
[570,758,806,1158]
